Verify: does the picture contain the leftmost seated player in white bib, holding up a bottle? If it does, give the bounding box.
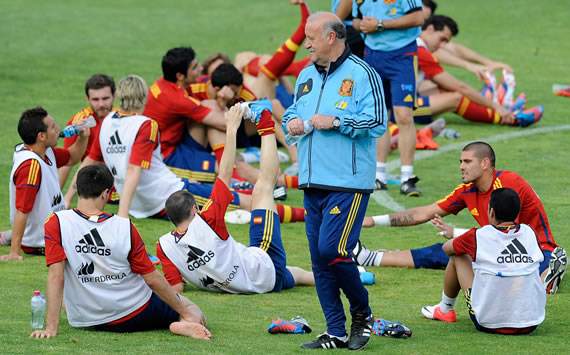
[0,107,89,260]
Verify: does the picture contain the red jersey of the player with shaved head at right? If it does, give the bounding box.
[437,170,558,251]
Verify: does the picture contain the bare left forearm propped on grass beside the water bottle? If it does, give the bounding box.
[30,261,65,338]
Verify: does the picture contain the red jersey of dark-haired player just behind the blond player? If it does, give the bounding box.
[143,78,211,157]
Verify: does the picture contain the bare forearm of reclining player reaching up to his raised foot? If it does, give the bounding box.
[218,104,243,186]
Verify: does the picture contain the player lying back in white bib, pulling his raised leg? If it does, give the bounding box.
[157,101,314,293]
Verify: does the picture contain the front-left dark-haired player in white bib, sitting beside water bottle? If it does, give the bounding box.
[31,165,211,339]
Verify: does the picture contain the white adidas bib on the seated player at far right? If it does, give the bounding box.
[471,224,546,329]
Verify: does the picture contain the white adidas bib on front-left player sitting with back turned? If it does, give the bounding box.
[56,210,152,327]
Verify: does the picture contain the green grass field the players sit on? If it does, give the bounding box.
[0,0,570,354]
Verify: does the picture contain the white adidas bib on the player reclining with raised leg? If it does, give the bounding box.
[159,215,275,293]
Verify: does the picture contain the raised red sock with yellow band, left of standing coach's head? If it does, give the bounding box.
[260,3,309,80]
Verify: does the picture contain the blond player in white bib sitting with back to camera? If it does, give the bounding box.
[73,75,302,224]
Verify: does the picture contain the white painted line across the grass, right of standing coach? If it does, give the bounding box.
[372,124,570,211]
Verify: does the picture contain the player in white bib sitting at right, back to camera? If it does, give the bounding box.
[422,188,546,335]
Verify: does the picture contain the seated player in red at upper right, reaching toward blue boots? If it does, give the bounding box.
[414,15,543,127]
